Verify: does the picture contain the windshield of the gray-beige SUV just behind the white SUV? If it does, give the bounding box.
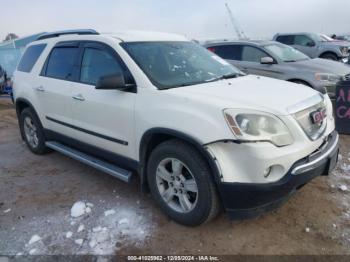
[265,43,310,62]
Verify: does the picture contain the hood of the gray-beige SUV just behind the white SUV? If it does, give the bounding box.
[292,58,350,76]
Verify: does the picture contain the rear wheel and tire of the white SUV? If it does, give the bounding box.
[19,107,49,155]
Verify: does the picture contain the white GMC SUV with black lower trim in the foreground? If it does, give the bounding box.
[14,30,338,226]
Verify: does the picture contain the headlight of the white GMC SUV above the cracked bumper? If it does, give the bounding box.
[224,109,293,146]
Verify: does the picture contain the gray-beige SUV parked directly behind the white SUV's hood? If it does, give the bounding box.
[204,40,350,98]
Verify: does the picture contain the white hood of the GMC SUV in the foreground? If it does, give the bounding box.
[163,75,319,115]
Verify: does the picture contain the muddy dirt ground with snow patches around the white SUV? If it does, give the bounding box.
[0,99,350,255]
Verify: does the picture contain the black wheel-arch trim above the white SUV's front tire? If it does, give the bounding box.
[139,127,220,188]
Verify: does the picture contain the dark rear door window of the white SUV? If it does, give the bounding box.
[45,47,79,80]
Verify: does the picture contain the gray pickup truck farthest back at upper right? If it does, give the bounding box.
[273,33,350,63]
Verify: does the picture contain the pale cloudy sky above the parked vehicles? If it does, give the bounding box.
[0,0,350,40]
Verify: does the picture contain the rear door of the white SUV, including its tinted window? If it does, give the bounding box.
[35,42,79,136]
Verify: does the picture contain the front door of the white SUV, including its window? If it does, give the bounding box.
[71,42,136,158]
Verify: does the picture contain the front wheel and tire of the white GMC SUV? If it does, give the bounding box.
[147,140,220,226]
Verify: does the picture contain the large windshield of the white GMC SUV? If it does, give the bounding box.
[121,42,242,89]
